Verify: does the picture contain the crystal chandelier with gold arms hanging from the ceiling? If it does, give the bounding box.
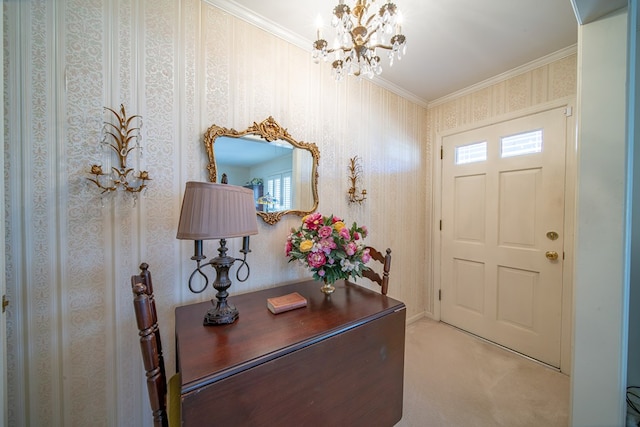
[313,0,407,80]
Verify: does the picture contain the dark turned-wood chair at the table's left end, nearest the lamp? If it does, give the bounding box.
[131,262,180,427]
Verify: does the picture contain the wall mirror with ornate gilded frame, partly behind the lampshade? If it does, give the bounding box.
[204,117,320,224]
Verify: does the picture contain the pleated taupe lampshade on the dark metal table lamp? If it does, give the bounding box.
[176,181,258,240]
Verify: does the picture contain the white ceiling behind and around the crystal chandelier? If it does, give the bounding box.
[205,0,578,104]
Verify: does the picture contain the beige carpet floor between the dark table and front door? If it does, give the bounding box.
[396,318,569,427]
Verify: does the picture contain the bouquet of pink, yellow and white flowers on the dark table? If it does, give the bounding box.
[285,212,371,283]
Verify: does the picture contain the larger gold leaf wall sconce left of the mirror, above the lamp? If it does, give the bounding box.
[87,104,151,199]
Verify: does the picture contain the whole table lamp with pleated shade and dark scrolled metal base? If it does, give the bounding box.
[176,181,258,325]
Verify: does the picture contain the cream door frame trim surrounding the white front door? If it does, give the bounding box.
[429,97,578,375]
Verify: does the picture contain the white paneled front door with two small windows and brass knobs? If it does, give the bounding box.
[440,107,566,367]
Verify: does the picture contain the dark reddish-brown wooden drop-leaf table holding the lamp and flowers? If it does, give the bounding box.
[176,281,406,427]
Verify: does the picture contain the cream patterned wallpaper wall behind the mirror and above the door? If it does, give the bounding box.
[3,0,575,426]
